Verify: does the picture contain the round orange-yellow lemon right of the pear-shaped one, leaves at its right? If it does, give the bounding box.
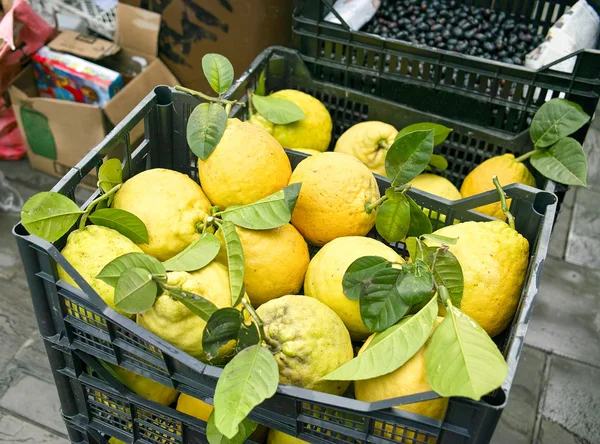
[290,152,380,246]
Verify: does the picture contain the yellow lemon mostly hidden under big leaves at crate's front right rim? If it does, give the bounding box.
[354,317,448,444]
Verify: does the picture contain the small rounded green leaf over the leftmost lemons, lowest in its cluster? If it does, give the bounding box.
[115,268,157,314]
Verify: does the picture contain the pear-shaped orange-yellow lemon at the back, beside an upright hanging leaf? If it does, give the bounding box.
[198,119,292,209]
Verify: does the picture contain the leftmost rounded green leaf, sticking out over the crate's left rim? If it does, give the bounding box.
[21,191,83,242]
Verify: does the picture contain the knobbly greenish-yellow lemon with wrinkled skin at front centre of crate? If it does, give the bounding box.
[256,295,354,395]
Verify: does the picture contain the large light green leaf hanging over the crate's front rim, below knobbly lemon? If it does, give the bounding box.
[214,345,279,439]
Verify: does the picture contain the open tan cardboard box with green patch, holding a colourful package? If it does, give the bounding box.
[8,4,179,185]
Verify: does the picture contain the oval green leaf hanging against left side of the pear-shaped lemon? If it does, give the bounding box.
[186,103,227,160]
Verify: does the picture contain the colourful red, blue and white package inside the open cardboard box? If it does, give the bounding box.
[32,46,123,106]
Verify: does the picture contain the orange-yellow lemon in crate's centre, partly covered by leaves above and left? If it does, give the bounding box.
[217,224,310,307]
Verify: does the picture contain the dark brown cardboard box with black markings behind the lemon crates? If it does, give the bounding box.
[121,0,293,93]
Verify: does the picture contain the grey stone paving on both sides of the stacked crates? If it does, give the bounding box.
[0,112,600,444]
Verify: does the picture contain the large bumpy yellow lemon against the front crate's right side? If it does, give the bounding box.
[427,221,529,337]
